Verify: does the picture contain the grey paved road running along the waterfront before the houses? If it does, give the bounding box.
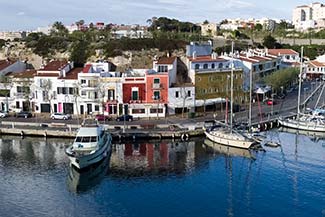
[2,82,325,126]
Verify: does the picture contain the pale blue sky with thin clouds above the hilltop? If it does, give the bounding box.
[0,0,313,31]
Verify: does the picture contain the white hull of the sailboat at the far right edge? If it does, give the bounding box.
[279,119,325,132]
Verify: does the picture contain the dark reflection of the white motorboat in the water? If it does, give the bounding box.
[67,155,110,192]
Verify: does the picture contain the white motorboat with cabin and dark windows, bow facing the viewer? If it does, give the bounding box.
[65,120,112,169]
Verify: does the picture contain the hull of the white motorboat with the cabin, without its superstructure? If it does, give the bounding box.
[67,135,112,170]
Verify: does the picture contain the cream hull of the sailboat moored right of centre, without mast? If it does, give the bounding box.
[205,131,254,149]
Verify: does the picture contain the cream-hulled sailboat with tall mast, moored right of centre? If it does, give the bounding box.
[204,42,255,149]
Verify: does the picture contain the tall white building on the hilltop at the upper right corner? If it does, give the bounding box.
[292,2,325,31]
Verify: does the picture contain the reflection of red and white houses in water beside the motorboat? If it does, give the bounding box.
[110,141,202,176]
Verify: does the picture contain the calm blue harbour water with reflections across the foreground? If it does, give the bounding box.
[0,132,325,217]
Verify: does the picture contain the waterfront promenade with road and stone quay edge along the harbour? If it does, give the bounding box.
[0,82,325,139]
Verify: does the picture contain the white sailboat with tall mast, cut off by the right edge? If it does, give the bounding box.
[279,47,325,132]
